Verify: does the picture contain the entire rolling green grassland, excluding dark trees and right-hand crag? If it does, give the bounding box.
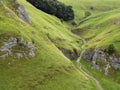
[0,0,120,90]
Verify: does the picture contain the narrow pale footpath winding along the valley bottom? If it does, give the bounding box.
[76,39,104,90]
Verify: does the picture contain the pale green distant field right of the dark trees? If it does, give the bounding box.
[59,0,120,21]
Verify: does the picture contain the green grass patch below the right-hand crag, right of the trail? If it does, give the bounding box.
[81,60,120,90]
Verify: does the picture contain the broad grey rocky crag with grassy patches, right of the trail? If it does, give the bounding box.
[82,49,120,75]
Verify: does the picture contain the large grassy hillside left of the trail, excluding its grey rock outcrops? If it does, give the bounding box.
[0,0,98,90]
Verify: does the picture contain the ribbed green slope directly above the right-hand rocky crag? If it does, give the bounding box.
[75,9,120,53]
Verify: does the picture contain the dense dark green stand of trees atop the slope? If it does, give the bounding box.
[27,0,74,21]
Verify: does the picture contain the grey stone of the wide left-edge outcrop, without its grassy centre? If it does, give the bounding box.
[0,37,35,59]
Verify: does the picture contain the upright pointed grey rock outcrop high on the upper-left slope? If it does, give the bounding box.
[16,5,31,24]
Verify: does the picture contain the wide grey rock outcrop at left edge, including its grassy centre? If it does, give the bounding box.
[0,37,35,59]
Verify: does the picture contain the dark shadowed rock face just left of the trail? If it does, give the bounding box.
[59,48,80,60]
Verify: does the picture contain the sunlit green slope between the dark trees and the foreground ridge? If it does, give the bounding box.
[19,0,81,50]
